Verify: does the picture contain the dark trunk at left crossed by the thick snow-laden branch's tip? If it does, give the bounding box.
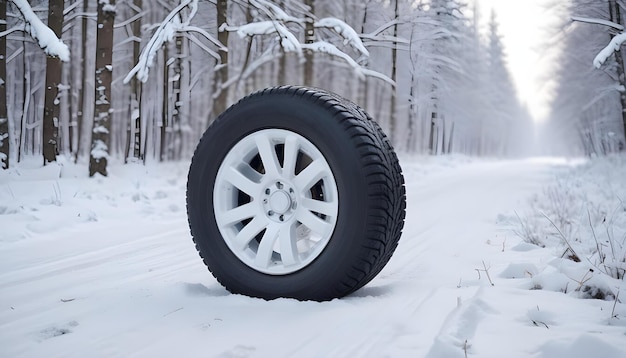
[43,0,63,165]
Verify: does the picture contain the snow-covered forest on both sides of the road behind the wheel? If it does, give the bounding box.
[0,0,626,175]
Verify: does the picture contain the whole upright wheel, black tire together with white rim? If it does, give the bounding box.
[187,86,406,301]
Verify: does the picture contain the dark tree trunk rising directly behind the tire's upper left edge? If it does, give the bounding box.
[213,0,229,117]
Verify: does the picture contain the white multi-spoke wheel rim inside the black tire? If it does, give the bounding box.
[213,129,339,275]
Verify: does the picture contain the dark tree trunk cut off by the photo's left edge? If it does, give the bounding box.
[0,1,9,169]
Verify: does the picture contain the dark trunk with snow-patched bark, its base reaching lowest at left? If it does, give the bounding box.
[89,0,115,176]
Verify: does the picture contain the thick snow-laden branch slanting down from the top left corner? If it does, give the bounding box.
[11,0,70,62]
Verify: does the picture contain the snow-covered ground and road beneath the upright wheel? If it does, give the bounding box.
[0,157,626,358]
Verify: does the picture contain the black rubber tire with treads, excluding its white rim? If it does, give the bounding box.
[187,86,406,301]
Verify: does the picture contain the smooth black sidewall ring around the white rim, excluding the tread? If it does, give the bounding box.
[187,93,369,300]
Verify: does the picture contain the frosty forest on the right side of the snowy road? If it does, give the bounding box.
[545,0,626,156]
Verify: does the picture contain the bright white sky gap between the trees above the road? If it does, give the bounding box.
[474,0,554,120]
